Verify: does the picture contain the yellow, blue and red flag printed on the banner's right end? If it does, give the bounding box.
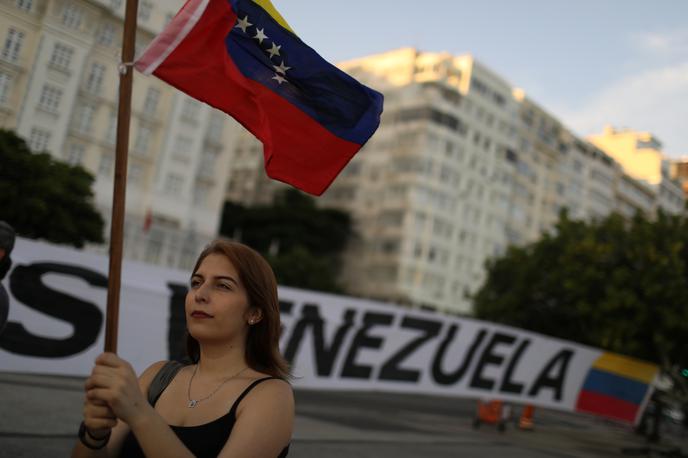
[576,353,657,423]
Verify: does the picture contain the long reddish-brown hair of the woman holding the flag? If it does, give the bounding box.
[186,239,290,378]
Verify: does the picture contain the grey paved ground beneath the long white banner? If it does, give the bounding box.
[0,372,688,458]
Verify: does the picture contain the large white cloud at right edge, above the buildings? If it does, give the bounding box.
[559,62,688,157]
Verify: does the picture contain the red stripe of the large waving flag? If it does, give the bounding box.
[154,1,360,195]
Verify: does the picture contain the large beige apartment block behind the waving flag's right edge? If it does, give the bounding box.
[227,48,684,313]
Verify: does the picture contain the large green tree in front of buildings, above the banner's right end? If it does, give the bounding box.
[473,212,688,367]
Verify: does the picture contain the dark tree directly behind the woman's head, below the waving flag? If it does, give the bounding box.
[220,189,353,293]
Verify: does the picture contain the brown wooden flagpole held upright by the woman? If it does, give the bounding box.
[105,0,138,353]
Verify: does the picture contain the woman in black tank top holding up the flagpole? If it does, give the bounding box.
[72,240,294,458]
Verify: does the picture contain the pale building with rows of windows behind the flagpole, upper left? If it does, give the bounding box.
[0,0,242,267]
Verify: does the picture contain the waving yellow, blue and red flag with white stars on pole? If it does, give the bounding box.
[135,0,383,195]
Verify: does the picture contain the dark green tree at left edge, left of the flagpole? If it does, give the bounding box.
[0,130,104,248]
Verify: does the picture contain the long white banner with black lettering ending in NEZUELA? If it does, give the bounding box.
[0,239,657,421]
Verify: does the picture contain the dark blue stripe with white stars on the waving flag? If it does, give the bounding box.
[225,0,382,145]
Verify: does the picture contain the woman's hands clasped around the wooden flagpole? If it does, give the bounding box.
[84,353,150,426]
